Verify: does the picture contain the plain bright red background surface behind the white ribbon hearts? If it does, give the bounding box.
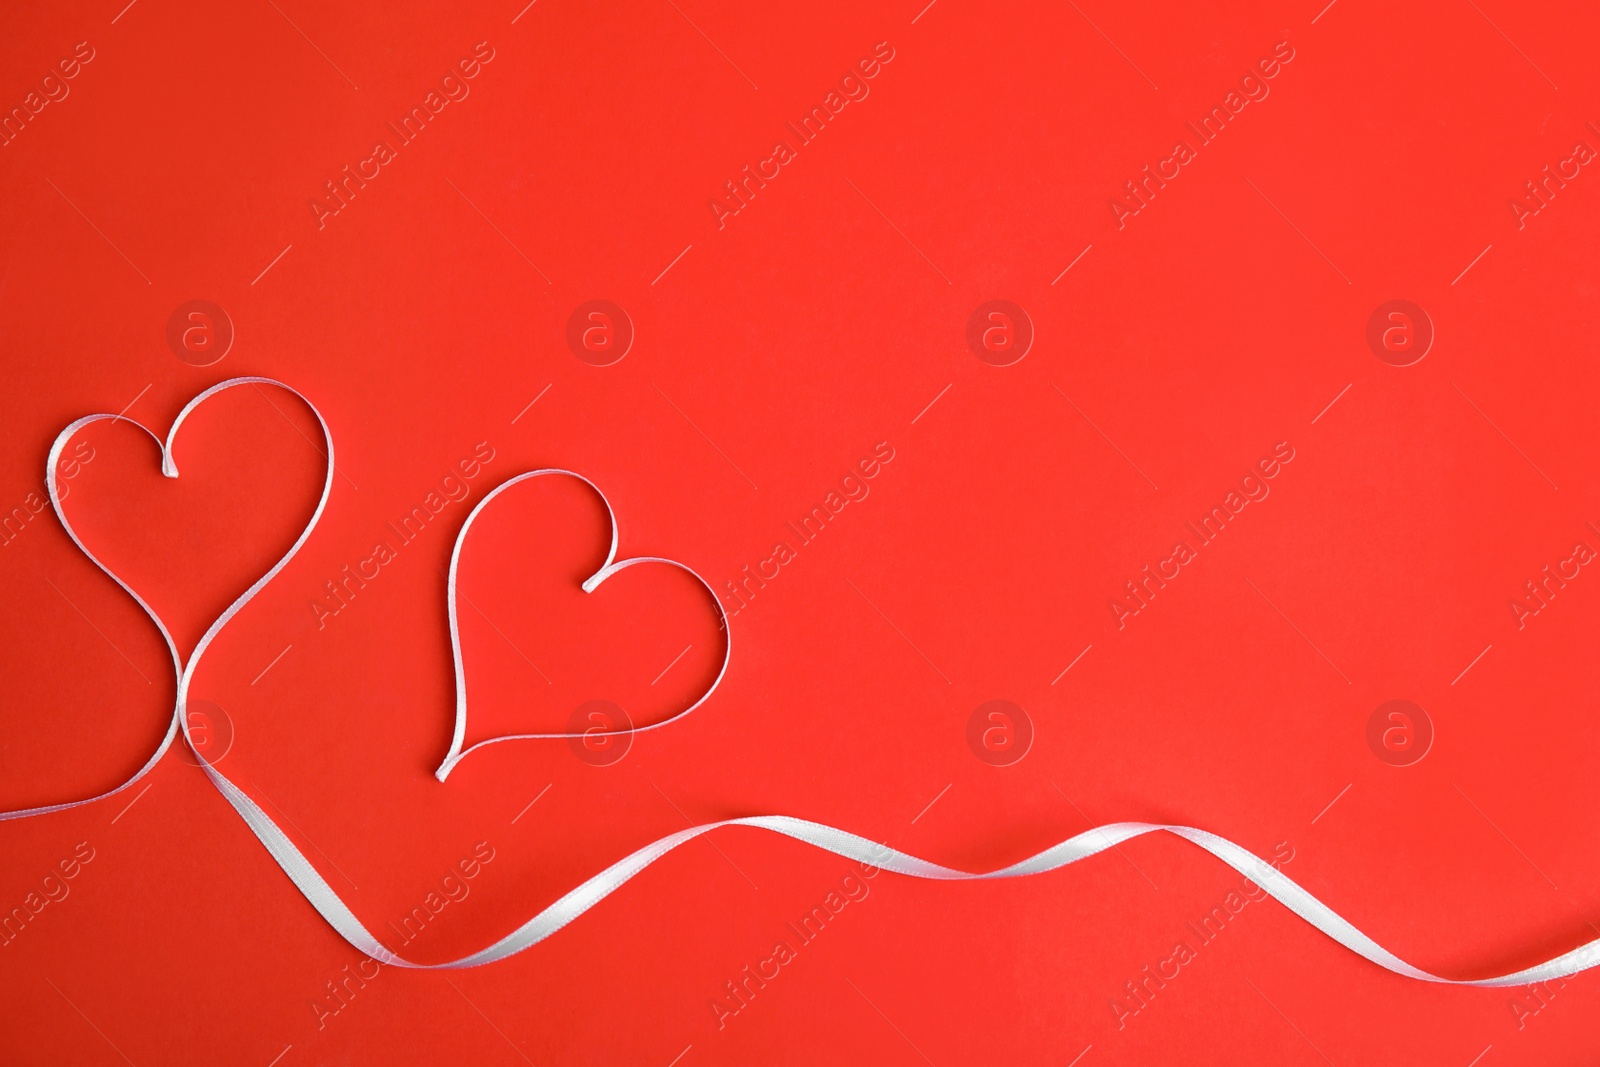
[0,0,1600,1067]
